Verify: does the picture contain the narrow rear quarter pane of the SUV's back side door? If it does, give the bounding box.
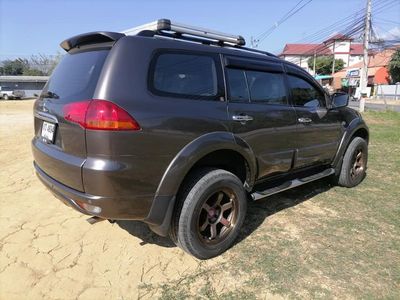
[226,69,249,102]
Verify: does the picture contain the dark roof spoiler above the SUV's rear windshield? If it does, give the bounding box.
[60,31,125,52]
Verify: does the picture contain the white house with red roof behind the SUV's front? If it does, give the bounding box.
[279,34,363,75]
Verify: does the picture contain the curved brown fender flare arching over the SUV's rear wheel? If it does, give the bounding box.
[145,131,257,236]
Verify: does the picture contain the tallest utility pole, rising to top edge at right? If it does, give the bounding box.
[360,0,372,112]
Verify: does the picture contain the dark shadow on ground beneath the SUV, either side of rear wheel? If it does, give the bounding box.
[116,179,332,248]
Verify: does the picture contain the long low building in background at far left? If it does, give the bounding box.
[0,76,49,98]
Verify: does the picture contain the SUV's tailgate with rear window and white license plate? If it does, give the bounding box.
[32,48,109,191]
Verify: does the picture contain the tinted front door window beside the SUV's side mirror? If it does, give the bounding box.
[288,75,325,107]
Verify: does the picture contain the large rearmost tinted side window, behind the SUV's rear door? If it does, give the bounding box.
[153,53,218,99]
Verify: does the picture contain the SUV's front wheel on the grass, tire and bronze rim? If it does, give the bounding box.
[337,137,368,188]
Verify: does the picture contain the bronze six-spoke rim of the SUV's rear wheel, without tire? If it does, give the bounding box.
[197,188,238,244]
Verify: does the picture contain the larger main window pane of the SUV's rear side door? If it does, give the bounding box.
[246,71,286,104]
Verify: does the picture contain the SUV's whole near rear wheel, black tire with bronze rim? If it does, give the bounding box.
[170,168,247,259]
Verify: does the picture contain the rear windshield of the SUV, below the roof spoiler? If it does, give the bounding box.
[42,50,109,100]
